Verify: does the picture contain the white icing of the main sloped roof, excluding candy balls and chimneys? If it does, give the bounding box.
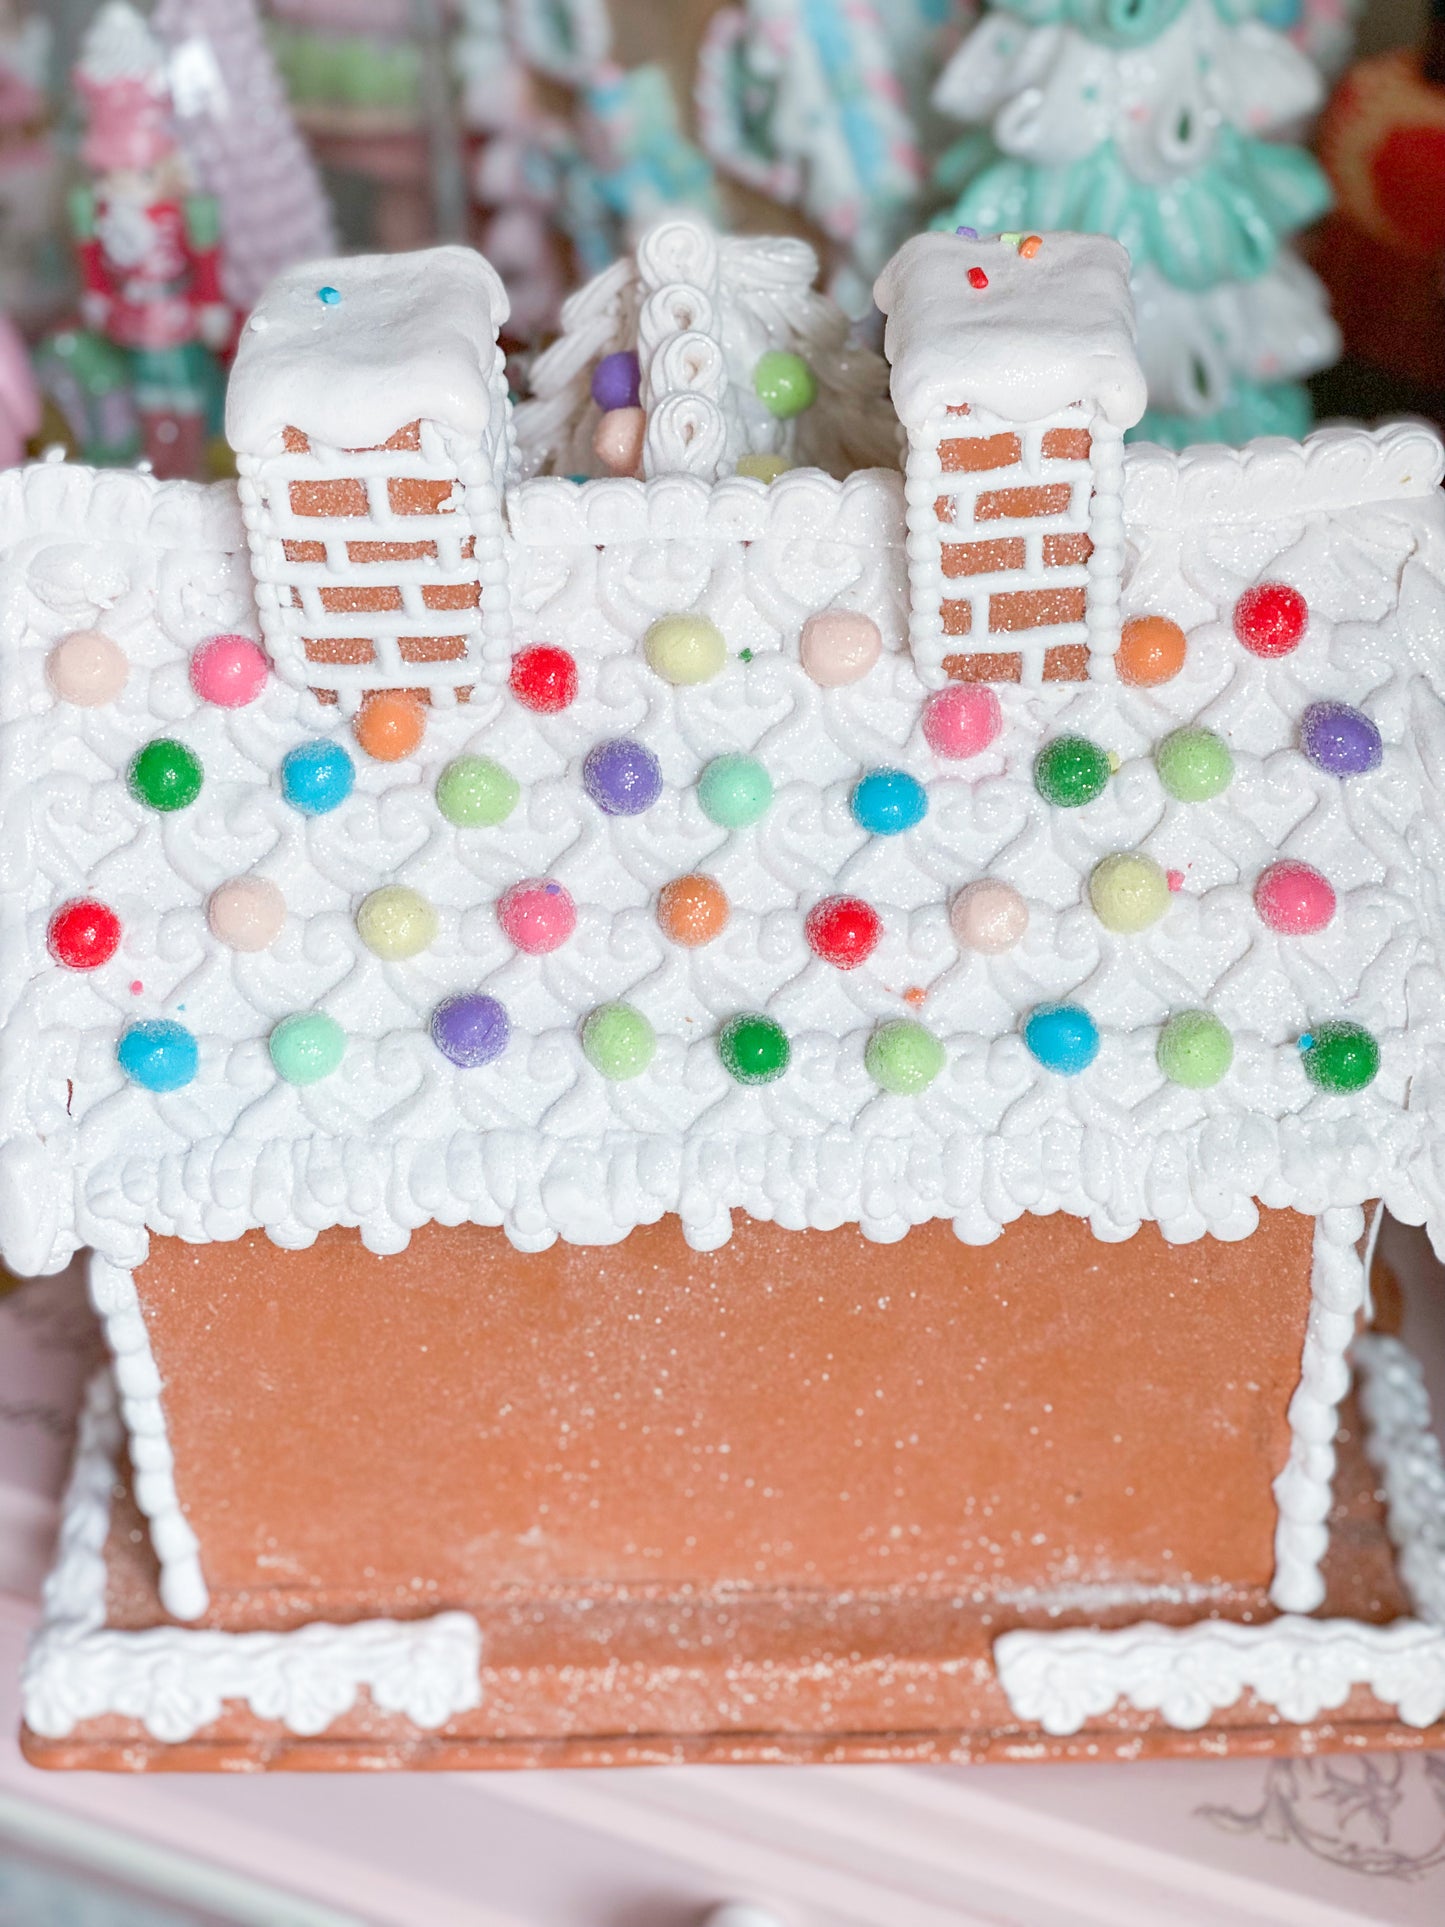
[0,426,1445,1270]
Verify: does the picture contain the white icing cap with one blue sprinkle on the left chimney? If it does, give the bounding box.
[225,247,509,455]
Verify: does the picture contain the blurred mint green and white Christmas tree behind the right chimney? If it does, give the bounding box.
[934,0,1339,447]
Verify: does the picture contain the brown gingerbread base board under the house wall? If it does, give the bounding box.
[23,1341,1445,1773]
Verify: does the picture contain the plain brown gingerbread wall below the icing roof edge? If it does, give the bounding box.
[137,1212,1312,1626]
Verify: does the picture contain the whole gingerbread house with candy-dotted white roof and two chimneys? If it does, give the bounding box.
[0,222,1445,1769]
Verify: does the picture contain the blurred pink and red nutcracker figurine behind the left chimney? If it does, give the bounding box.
[62,0,235,478]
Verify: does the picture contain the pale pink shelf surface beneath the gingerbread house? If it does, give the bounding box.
[0,1239,1445,1927]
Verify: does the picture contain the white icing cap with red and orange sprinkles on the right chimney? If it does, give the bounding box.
[873,233,1148,430]
